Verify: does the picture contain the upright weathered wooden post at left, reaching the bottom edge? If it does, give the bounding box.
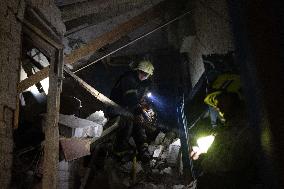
[42,49,63,189]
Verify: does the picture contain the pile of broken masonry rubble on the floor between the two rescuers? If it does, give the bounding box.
[87,132,195,189]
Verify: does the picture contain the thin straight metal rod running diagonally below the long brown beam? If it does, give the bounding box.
[73,11,191,73]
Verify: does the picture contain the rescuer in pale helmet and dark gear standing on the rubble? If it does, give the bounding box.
[110,60,154,162]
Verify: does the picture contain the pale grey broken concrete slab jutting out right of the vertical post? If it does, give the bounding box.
[59,114,103,137]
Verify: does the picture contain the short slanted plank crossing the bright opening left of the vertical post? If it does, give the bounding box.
[17,67,49,94]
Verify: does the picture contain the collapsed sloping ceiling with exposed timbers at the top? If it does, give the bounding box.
[55,0,191,70]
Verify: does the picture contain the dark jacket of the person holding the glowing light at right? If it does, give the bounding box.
[200,111,257,189]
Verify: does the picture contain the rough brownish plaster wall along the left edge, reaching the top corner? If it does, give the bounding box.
[0,0,65,189]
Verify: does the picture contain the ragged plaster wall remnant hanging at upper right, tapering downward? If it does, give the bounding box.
[183,0,234,86]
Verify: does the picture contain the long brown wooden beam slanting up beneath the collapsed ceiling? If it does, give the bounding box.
[64,2,165,64]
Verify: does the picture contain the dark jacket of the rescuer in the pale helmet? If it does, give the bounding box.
[110,71,150,112]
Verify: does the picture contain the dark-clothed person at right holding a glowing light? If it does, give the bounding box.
[191,91,257,189]
